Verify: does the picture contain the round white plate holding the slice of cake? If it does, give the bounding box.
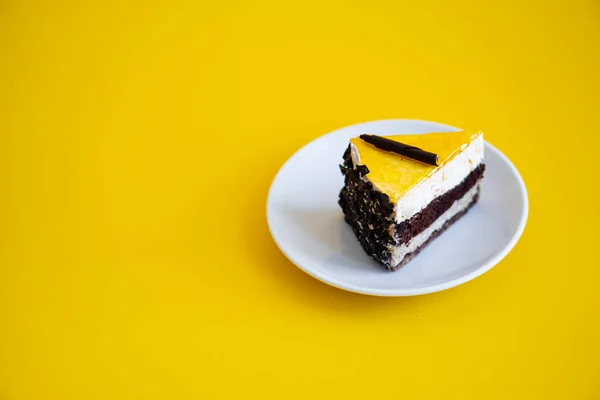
[267,120,528,296]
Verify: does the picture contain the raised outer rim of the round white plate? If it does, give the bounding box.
[266,118,529,297]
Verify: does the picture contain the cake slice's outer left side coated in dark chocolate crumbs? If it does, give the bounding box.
[339,146,396,268]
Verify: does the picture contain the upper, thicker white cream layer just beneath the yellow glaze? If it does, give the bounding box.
[392,135,483,223]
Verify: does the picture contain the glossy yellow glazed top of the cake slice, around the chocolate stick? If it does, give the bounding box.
[350,131,482,202]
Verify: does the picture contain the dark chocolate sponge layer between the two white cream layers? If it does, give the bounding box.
[395,163,485,245]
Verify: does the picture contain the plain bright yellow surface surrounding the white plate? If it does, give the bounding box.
[0,0,600,400]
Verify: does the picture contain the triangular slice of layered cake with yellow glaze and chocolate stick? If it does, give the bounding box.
[339,131,485,271]
